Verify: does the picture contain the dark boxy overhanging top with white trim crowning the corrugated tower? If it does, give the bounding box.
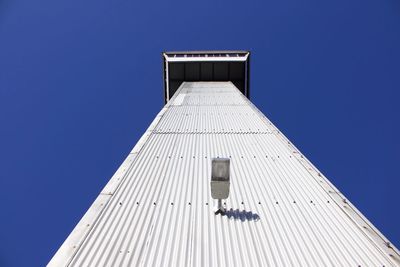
[163,51,250,103]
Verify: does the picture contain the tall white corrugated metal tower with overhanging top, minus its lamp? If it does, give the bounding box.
[49,51,400,266]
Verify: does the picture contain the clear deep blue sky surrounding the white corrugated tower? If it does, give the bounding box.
[0,0,400,266]
